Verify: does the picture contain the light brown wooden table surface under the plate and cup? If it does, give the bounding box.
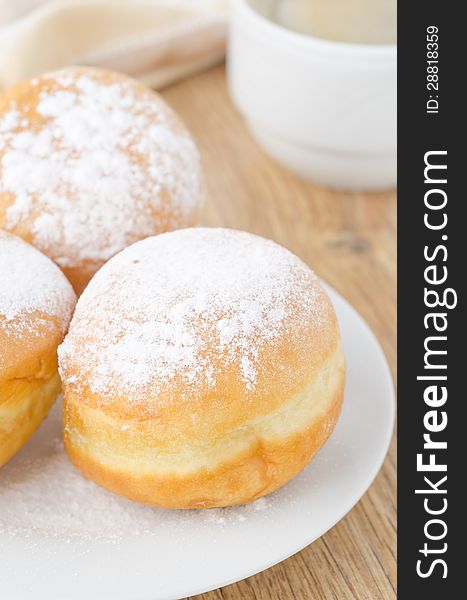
[163,67,396,600]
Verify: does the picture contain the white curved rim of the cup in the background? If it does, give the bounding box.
[235,0,397,59]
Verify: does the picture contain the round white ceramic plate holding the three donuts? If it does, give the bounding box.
[0,290,394,600]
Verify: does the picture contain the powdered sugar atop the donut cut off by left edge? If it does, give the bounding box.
[0,230,75,331]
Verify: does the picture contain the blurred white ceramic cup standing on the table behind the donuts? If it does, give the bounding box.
[228,0,397,191]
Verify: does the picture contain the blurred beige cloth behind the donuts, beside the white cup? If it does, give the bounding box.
[0,0,229,89]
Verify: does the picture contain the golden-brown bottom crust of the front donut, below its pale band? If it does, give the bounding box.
[64,378,343,509]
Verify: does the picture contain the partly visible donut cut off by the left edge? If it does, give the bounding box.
[0,231,76,466]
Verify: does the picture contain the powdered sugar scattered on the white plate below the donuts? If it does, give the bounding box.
[0,401,274,543]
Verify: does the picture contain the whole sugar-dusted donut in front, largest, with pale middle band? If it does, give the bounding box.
[58,228,344,508]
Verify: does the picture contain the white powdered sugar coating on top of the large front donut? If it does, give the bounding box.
[59,228,326,411]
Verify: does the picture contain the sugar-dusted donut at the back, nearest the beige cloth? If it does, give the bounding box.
[0,67,202,294]
